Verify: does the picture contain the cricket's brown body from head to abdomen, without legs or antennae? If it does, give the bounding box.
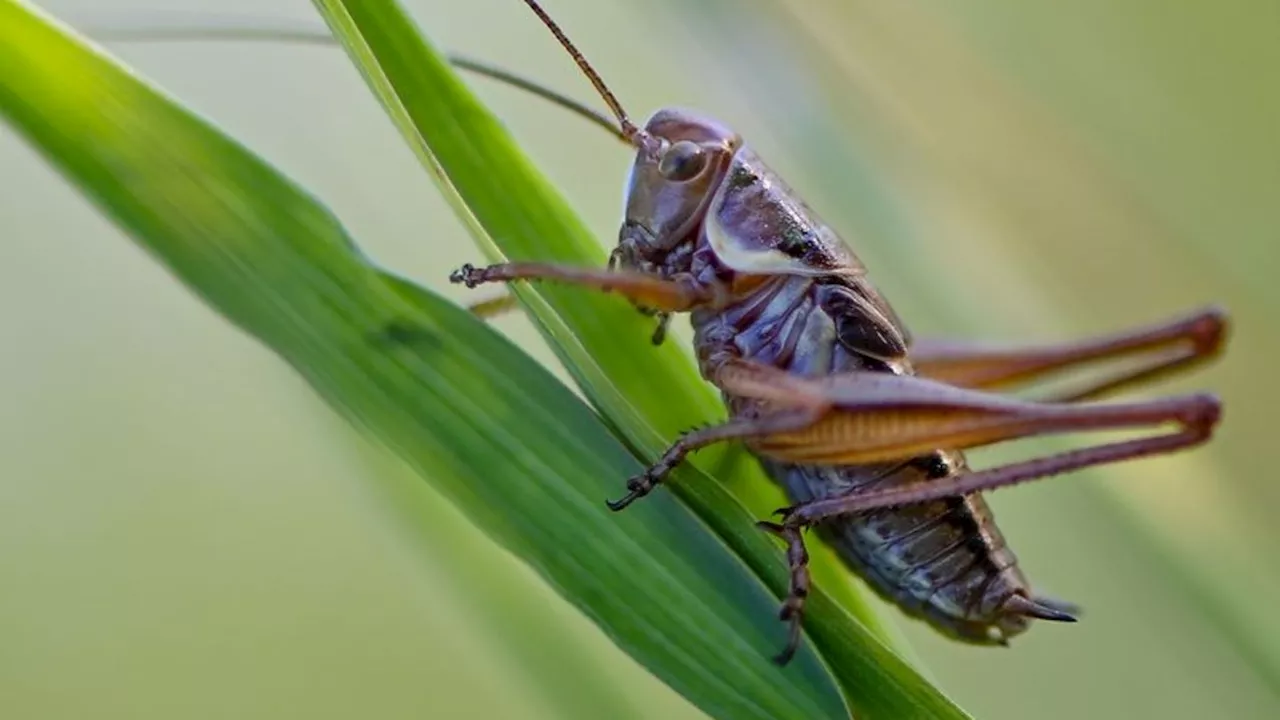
[616,110,1032,643]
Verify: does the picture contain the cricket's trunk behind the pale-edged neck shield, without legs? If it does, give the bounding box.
[694,275,1030,644]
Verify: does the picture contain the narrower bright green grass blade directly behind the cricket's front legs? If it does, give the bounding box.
[309,0,964,717]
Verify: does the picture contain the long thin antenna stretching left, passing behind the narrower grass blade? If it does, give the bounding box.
[77,17,634,143]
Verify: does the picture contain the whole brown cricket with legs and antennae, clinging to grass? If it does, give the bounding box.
[99,0,1228,665]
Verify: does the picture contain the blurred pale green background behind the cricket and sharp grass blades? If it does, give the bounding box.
[0,0,1280,719]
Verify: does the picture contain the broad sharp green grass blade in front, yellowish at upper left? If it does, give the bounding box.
[0,0,870,717]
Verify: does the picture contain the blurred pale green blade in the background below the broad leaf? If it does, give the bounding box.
[340,438,675,720]
